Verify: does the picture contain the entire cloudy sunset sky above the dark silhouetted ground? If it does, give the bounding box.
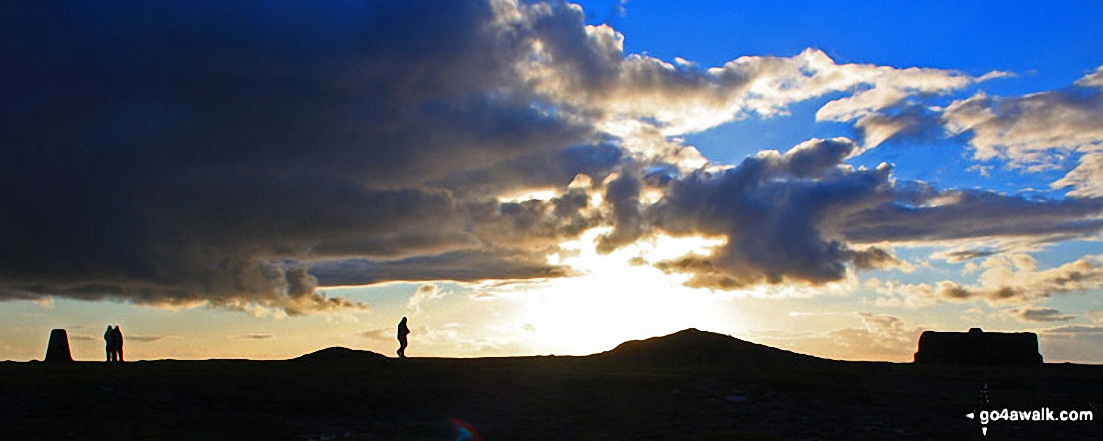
[0,0,1103,363]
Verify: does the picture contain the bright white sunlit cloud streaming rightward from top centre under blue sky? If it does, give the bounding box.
[523,10,998,136]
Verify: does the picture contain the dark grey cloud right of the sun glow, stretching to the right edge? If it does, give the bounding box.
[646,139,1103,291]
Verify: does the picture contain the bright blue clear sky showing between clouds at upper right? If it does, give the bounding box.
[580,0,1103,191]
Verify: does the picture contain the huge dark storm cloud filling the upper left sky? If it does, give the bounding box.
[0,1,621,313]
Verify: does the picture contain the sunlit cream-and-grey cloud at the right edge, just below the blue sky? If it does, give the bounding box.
[833,67,1103,197]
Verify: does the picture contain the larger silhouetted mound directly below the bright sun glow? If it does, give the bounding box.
[595,327,827,364]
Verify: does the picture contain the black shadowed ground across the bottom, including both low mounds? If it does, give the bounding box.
[0,331,1103,440]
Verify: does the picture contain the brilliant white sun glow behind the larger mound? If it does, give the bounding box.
[486,228,743,354]
